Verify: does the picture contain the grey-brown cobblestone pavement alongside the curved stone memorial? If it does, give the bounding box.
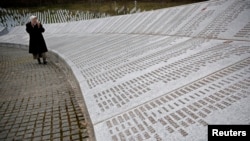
[0,47,89,141]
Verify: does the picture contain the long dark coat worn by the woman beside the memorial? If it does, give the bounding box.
[26,22,48,54]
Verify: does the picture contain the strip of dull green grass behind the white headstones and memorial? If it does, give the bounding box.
[13,0,207,15]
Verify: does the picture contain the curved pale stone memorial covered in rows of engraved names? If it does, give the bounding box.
[0,0,250,141]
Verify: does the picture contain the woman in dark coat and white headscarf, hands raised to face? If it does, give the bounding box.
[26,16,48,64]
